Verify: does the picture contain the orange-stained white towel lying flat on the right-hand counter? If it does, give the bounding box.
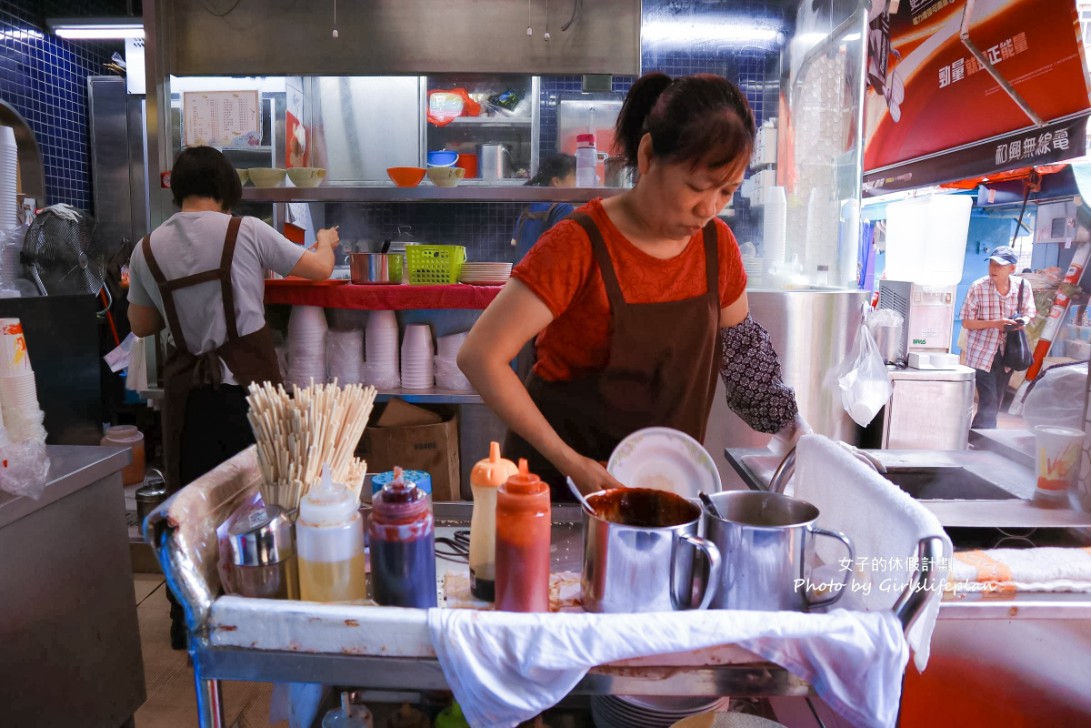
[950,547,1091,592]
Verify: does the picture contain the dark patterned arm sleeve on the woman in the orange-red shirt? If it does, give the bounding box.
[720,314,799,433]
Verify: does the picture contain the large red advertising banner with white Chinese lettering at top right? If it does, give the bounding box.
[864,0,1089,194]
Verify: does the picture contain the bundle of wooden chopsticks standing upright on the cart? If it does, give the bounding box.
[247,380,375,512]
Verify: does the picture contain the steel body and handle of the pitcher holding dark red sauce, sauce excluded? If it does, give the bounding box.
[582,488,720,612]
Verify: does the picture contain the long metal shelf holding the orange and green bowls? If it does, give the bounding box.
[242,180,621,202]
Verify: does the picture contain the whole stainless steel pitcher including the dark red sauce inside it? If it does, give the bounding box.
[582,488,720,612]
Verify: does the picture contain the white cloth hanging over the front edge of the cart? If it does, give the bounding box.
[428,609,909,728]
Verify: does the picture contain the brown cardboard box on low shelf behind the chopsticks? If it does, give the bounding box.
[358,398,460,501]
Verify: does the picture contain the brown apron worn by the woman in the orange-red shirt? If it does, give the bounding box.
[504,213,720,500]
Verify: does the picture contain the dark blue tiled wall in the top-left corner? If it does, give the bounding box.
[0,0,125,210]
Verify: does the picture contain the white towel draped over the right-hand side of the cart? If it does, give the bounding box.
[792,434,951,670]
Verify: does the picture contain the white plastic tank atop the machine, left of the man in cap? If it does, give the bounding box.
[885,194,973,286]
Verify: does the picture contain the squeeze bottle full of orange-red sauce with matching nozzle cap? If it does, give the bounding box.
[496,457,551,611]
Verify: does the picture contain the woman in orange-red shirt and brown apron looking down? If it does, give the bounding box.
[458,73,798,500]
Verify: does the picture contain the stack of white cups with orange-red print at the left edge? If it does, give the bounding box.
[0,319,46,444]
